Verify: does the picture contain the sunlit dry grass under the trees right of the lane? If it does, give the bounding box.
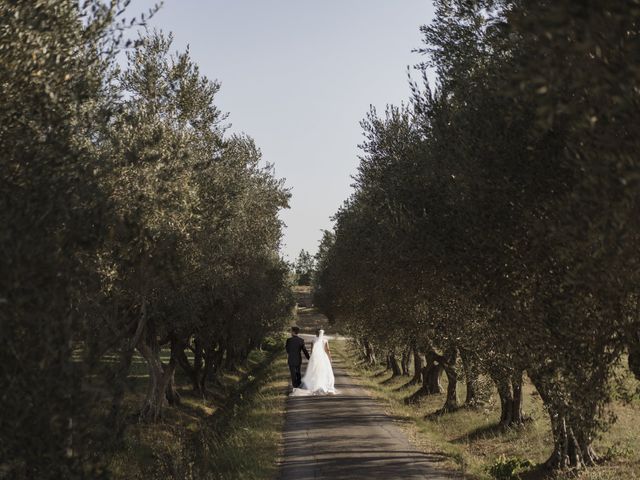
[335,342,640,480]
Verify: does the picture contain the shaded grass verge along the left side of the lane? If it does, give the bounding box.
[110,349,287,480]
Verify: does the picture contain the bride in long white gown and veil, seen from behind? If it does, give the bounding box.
[291,329,336,396]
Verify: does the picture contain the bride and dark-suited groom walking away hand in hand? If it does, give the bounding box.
[286,327,337,397]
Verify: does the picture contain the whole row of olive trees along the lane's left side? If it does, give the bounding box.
[0,0,292,479]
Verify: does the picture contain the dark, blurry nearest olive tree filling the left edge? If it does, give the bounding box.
[0,0,148,479]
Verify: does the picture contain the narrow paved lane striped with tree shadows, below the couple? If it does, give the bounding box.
[280,348,457,480]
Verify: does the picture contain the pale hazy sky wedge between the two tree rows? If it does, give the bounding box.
[133,0,433,259]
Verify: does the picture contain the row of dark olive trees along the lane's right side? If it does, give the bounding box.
[314,0,640,468]
